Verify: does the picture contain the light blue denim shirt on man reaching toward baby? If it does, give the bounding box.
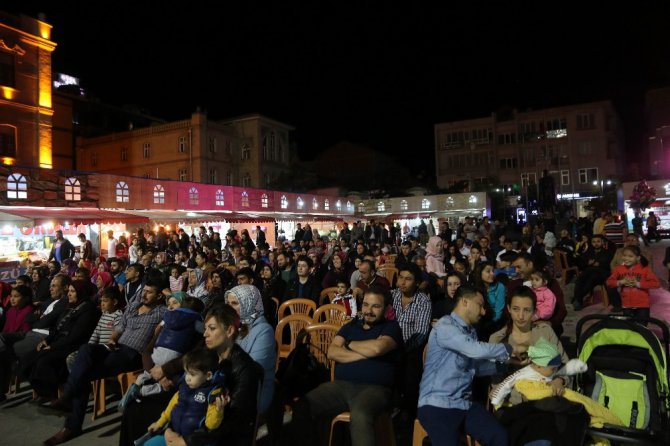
[419,313,512,410]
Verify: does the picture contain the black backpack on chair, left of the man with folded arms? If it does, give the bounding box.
[275,329,330,398]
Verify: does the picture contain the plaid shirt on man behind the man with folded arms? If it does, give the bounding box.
[391,288,432,350]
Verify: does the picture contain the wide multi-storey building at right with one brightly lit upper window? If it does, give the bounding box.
[435,101,624,218]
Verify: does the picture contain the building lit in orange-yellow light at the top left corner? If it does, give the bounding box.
[0,12,56,168]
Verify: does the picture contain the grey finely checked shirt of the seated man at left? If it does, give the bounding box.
[114,301,166,353]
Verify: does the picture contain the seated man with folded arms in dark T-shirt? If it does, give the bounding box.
[292,286,403,446]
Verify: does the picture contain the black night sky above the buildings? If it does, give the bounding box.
[7,0,670,173]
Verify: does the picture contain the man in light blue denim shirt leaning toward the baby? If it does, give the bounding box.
[418,286,518,446]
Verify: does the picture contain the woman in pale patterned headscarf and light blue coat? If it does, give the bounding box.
[225,285,277,413]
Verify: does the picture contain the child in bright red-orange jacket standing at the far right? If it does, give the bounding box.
[606,246,661,318]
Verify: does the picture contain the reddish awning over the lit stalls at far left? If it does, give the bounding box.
[0,207,149,226]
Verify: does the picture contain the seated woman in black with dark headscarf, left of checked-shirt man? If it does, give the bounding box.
[19,280,101,399]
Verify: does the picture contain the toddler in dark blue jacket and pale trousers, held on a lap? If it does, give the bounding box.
[119,291,204,408]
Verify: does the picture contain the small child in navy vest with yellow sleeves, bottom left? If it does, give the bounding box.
[144,348,230,446]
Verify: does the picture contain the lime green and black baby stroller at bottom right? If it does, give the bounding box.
[577,314,670,445]
